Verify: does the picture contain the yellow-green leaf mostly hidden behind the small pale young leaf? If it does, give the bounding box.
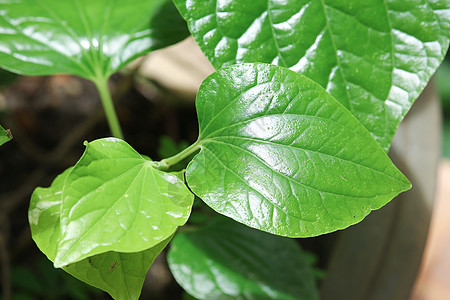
[29,169,170,300]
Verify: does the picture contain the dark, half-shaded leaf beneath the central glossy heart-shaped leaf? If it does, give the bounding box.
[167,220,319,300]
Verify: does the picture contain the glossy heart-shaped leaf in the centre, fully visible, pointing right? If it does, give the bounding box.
[186,64,410,237]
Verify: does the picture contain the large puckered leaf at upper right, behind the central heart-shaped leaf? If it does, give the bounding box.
[174,0,450,149]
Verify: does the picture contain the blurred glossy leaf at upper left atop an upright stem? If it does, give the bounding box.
[0,0,188,80]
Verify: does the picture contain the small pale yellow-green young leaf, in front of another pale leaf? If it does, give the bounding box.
[55,138,194,267]
